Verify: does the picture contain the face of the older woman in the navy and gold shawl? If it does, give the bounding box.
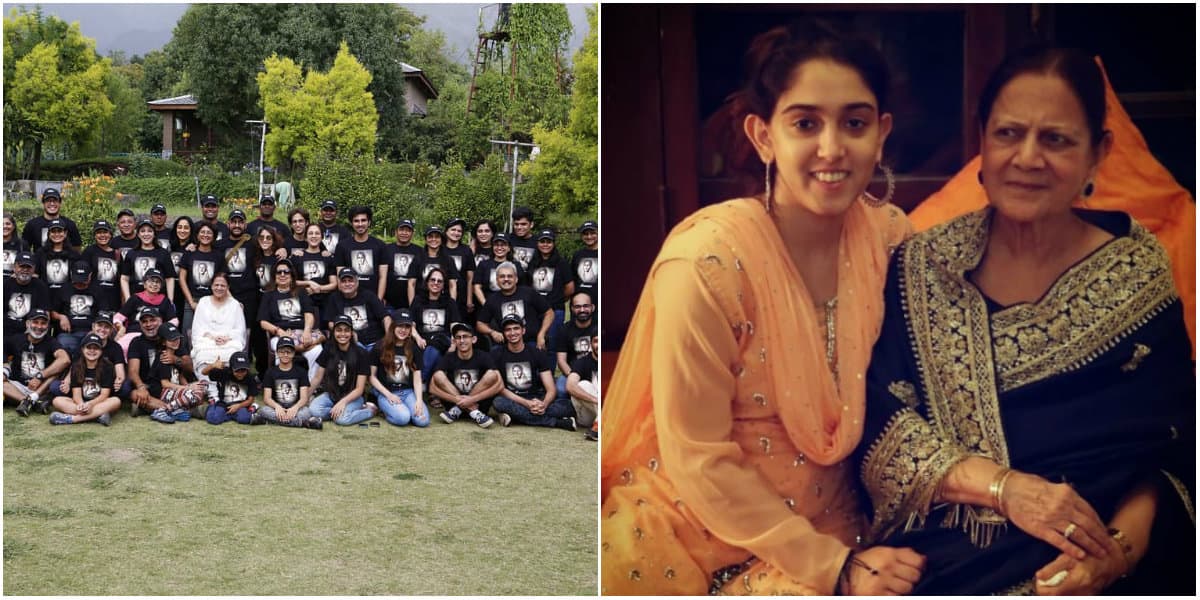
[980,73,1111,222]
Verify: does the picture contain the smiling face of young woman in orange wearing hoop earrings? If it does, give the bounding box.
[744,59,892,216]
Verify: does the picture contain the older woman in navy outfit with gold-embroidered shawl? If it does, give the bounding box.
[858,48,1195,595]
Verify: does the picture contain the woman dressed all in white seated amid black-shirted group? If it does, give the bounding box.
[192,273,246,379]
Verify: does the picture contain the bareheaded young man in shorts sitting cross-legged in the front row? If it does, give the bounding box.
[430,323,503,428]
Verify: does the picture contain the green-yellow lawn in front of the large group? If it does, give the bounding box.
[4,409,598,595]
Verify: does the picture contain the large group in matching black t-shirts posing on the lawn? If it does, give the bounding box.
[4,194,600,440]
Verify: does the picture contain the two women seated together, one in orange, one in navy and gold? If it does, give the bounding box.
[601,23,1195,595]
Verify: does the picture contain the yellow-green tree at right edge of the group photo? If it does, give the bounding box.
[521,7,599,214]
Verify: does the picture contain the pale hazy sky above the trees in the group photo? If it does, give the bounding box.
[4,2,588,67]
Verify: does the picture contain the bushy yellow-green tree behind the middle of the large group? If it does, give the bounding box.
[258,42,379,169]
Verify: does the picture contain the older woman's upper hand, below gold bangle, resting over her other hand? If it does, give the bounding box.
[1000,472,1104,560]
